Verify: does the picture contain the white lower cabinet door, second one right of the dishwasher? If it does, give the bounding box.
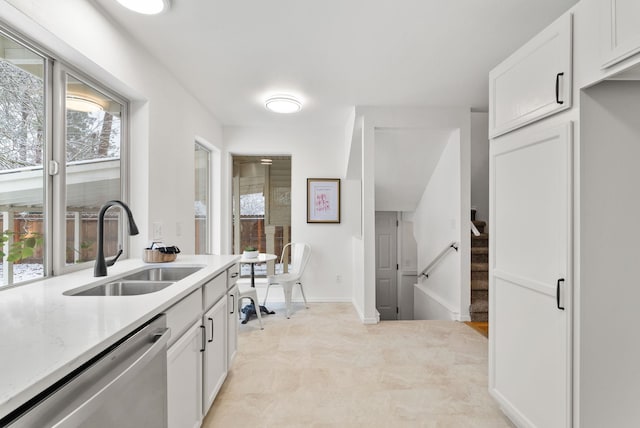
[202,298,228,413]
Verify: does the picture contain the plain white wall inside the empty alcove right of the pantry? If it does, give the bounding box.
[576,81,640,428]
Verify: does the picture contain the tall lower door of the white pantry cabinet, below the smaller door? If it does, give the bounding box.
[489,123,572,428]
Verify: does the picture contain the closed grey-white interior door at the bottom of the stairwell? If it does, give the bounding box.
[376,211,398,320]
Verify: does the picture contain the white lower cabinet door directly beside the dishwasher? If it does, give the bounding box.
[167,321,204,428]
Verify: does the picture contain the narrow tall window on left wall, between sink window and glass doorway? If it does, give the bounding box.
[194,142,211,254]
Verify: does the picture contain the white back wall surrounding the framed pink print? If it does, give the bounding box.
[223,127,360,302]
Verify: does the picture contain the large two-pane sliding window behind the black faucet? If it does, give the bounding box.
[0,31,127,287]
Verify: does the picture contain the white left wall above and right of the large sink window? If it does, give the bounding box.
[0,0,224,257]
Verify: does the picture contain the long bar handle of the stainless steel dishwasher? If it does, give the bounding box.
[53,328,171,428]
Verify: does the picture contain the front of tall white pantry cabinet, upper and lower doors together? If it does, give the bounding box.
[489,9,574,428]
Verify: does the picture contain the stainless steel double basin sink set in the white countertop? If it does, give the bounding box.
[63,266,202,296]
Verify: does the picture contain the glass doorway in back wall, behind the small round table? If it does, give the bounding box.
[232,155,291,278]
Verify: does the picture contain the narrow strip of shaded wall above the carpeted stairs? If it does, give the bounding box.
[471,112,489,225]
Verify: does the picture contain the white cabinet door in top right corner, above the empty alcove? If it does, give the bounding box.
[600,0,640,68]
